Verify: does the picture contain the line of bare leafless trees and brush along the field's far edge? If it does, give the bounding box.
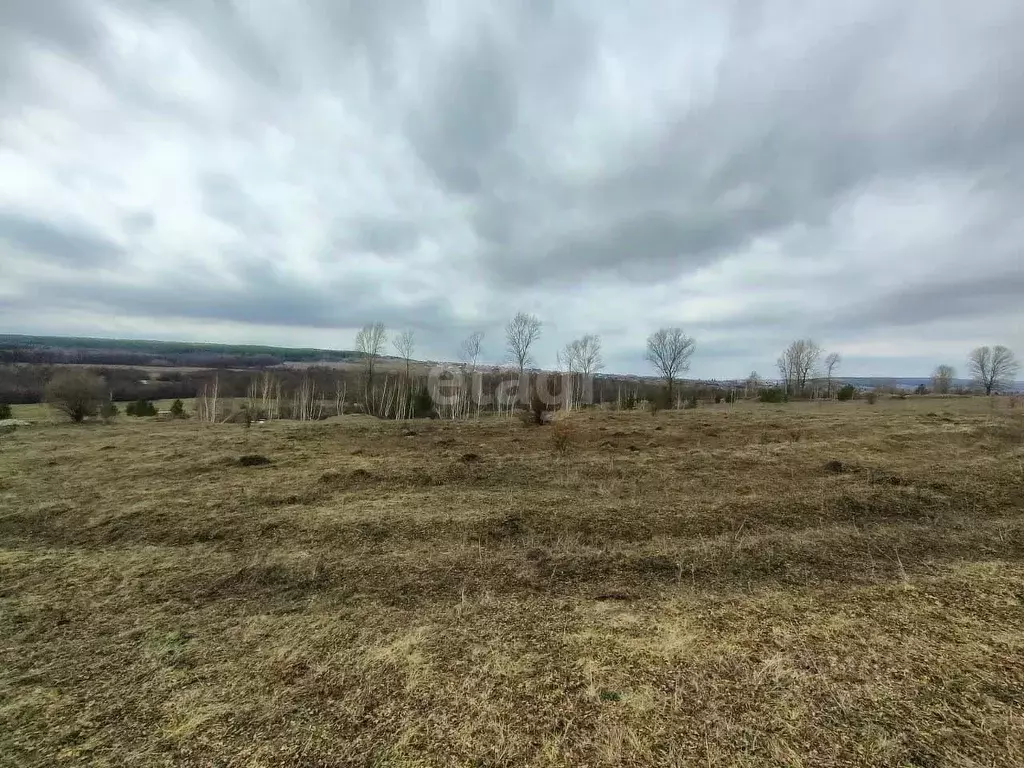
[0,312,1019,421]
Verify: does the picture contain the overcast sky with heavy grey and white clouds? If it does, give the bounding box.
[0,0,1024,378]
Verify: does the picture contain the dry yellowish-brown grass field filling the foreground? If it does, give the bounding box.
[0,397,1024,767]
